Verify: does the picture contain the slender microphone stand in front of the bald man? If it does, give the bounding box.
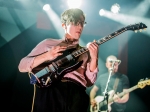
[104,61,115,112]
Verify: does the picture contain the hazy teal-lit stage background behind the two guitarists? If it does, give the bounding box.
[0,0,150,112]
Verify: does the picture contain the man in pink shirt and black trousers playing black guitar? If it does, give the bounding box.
[18,8,98,112]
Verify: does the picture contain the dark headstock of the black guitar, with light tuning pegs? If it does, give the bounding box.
[126,22,147,32]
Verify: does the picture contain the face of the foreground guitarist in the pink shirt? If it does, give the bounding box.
[65,17,84,40]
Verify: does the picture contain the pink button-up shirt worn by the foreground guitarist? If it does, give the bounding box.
[18,39,98,87]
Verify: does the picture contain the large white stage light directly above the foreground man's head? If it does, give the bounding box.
[67,0,82,8]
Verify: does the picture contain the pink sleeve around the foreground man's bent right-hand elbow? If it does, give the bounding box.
[85,63,99,87]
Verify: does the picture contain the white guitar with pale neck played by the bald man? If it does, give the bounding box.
[90,79,150,112]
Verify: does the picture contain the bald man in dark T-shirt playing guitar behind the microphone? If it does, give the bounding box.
[90,55,129,112]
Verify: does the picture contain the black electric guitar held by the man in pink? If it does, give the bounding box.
[29,22,147,87]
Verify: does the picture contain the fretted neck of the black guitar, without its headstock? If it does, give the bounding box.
[72,28,127,57]
